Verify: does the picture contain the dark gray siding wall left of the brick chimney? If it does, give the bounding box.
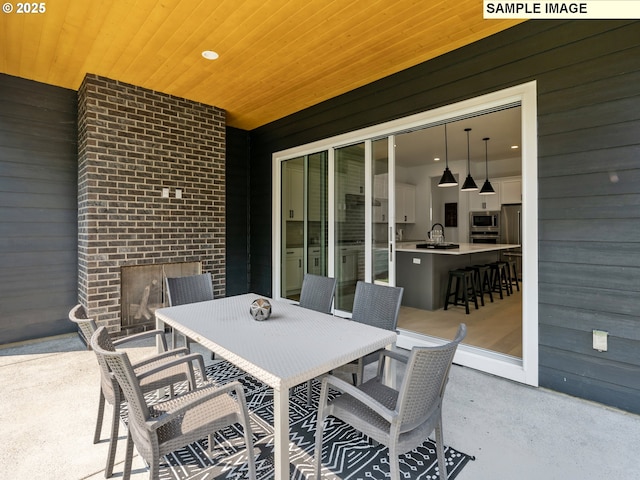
[0,75,77,344]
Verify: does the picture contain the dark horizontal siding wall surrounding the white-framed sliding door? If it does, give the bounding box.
[251,21,640,413]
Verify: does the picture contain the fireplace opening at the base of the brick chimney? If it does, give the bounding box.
[120,262,202,334]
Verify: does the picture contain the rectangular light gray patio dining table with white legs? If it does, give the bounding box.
[155,293,396,480]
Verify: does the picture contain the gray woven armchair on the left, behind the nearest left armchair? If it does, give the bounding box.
[69,305,206,478]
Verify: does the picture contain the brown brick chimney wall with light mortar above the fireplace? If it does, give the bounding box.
[78,75,225,332]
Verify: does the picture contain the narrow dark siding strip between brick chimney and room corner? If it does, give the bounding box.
[225,127,249,296]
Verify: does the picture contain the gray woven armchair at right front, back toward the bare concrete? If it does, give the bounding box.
[315,324,467,480]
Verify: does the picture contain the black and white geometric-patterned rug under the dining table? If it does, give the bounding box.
[123,361,474,480]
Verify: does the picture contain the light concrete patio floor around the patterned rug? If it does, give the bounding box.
[0,334,640,480]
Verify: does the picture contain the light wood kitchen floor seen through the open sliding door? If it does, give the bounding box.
[398,284,522,358]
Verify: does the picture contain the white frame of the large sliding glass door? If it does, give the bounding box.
[272,81,538,386]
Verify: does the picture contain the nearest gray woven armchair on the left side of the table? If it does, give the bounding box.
[91,327,256,480]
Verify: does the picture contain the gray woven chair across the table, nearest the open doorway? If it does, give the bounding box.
[336,281,404,385]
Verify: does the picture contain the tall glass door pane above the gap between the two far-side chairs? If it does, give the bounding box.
[334,143,365,312]
